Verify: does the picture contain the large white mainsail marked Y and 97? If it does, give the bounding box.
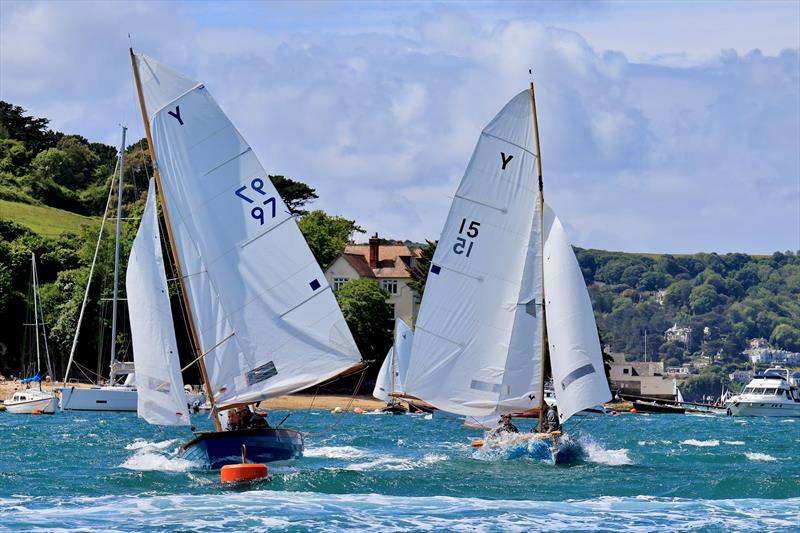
[137,55,361,407]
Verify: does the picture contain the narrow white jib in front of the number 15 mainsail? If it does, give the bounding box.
[544,206,611,423]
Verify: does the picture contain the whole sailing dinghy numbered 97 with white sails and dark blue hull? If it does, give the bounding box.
[127,50,363,468]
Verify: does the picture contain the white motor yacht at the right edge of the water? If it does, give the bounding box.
[725,367,800,416]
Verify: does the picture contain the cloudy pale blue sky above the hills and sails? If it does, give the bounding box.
[0,0,800,253]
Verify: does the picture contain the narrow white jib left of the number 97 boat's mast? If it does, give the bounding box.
[125,180,190,426]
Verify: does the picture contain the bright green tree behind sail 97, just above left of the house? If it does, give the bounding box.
[298,210,364,270]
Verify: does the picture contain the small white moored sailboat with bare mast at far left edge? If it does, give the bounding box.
[3,252,56,414]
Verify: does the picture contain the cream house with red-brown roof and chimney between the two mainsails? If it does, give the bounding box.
[325,233,418,325]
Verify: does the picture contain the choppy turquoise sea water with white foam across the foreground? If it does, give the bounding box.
[0,411,800,531]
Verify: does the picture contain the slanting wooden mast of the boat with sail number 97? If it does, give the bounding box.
[129,48,222,431]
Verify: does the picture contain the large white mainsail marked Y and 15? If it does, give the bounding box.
[405,91,542,416]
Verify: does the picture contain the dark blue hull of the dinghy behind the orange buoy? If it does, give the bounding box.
[180,428,303,470]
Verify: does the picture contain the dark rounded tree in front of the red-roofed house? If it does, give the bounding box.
[336,278,392,372]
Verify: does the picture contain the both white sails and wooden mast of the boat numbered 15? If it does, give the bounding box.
[405,75,611,462]
